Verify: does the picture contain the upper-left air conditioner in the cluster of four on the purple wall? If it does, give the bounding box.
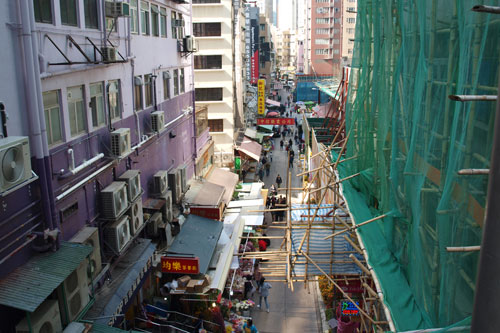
[101,182,128,219]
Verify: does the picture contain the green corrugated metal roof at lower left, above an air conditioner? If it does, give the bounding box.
[0,242,92,312]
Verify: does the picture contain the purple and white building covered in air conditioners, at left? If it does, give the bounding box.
[0,0,198,326]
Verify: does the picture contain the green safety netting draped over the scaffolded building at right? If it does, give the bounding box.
[332,0,500,331]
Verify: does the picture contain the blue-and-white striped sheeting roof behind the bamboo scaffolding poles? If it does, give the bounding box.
[291,205,363,275]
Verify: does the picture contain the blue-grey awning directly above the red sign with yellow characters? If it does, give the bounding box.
[168,214,223,274]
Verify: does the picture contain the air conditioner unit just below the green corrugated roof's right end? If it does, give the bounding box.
[64,259,90,321]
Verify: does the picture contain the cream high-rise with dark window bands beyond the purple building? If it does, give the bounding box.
[193,0,245,165]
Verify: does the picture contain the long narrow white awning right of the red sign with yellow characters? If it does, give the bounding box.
[208,217,243,292]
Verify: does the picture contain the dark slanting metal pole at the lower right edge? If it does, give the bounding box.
[471,74,500,333]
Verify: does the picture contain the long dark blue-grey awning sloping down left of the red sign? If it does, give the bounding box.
[85,238,156,324]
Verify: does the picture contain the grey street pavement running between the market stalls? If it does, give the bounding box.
[252,90,320,333]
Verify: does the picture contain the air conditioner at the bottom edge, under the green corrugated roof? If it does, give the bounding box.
[16,299,62,333]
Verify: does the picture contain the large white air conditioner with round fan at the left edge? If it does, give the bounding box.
[0,136,31,193]
